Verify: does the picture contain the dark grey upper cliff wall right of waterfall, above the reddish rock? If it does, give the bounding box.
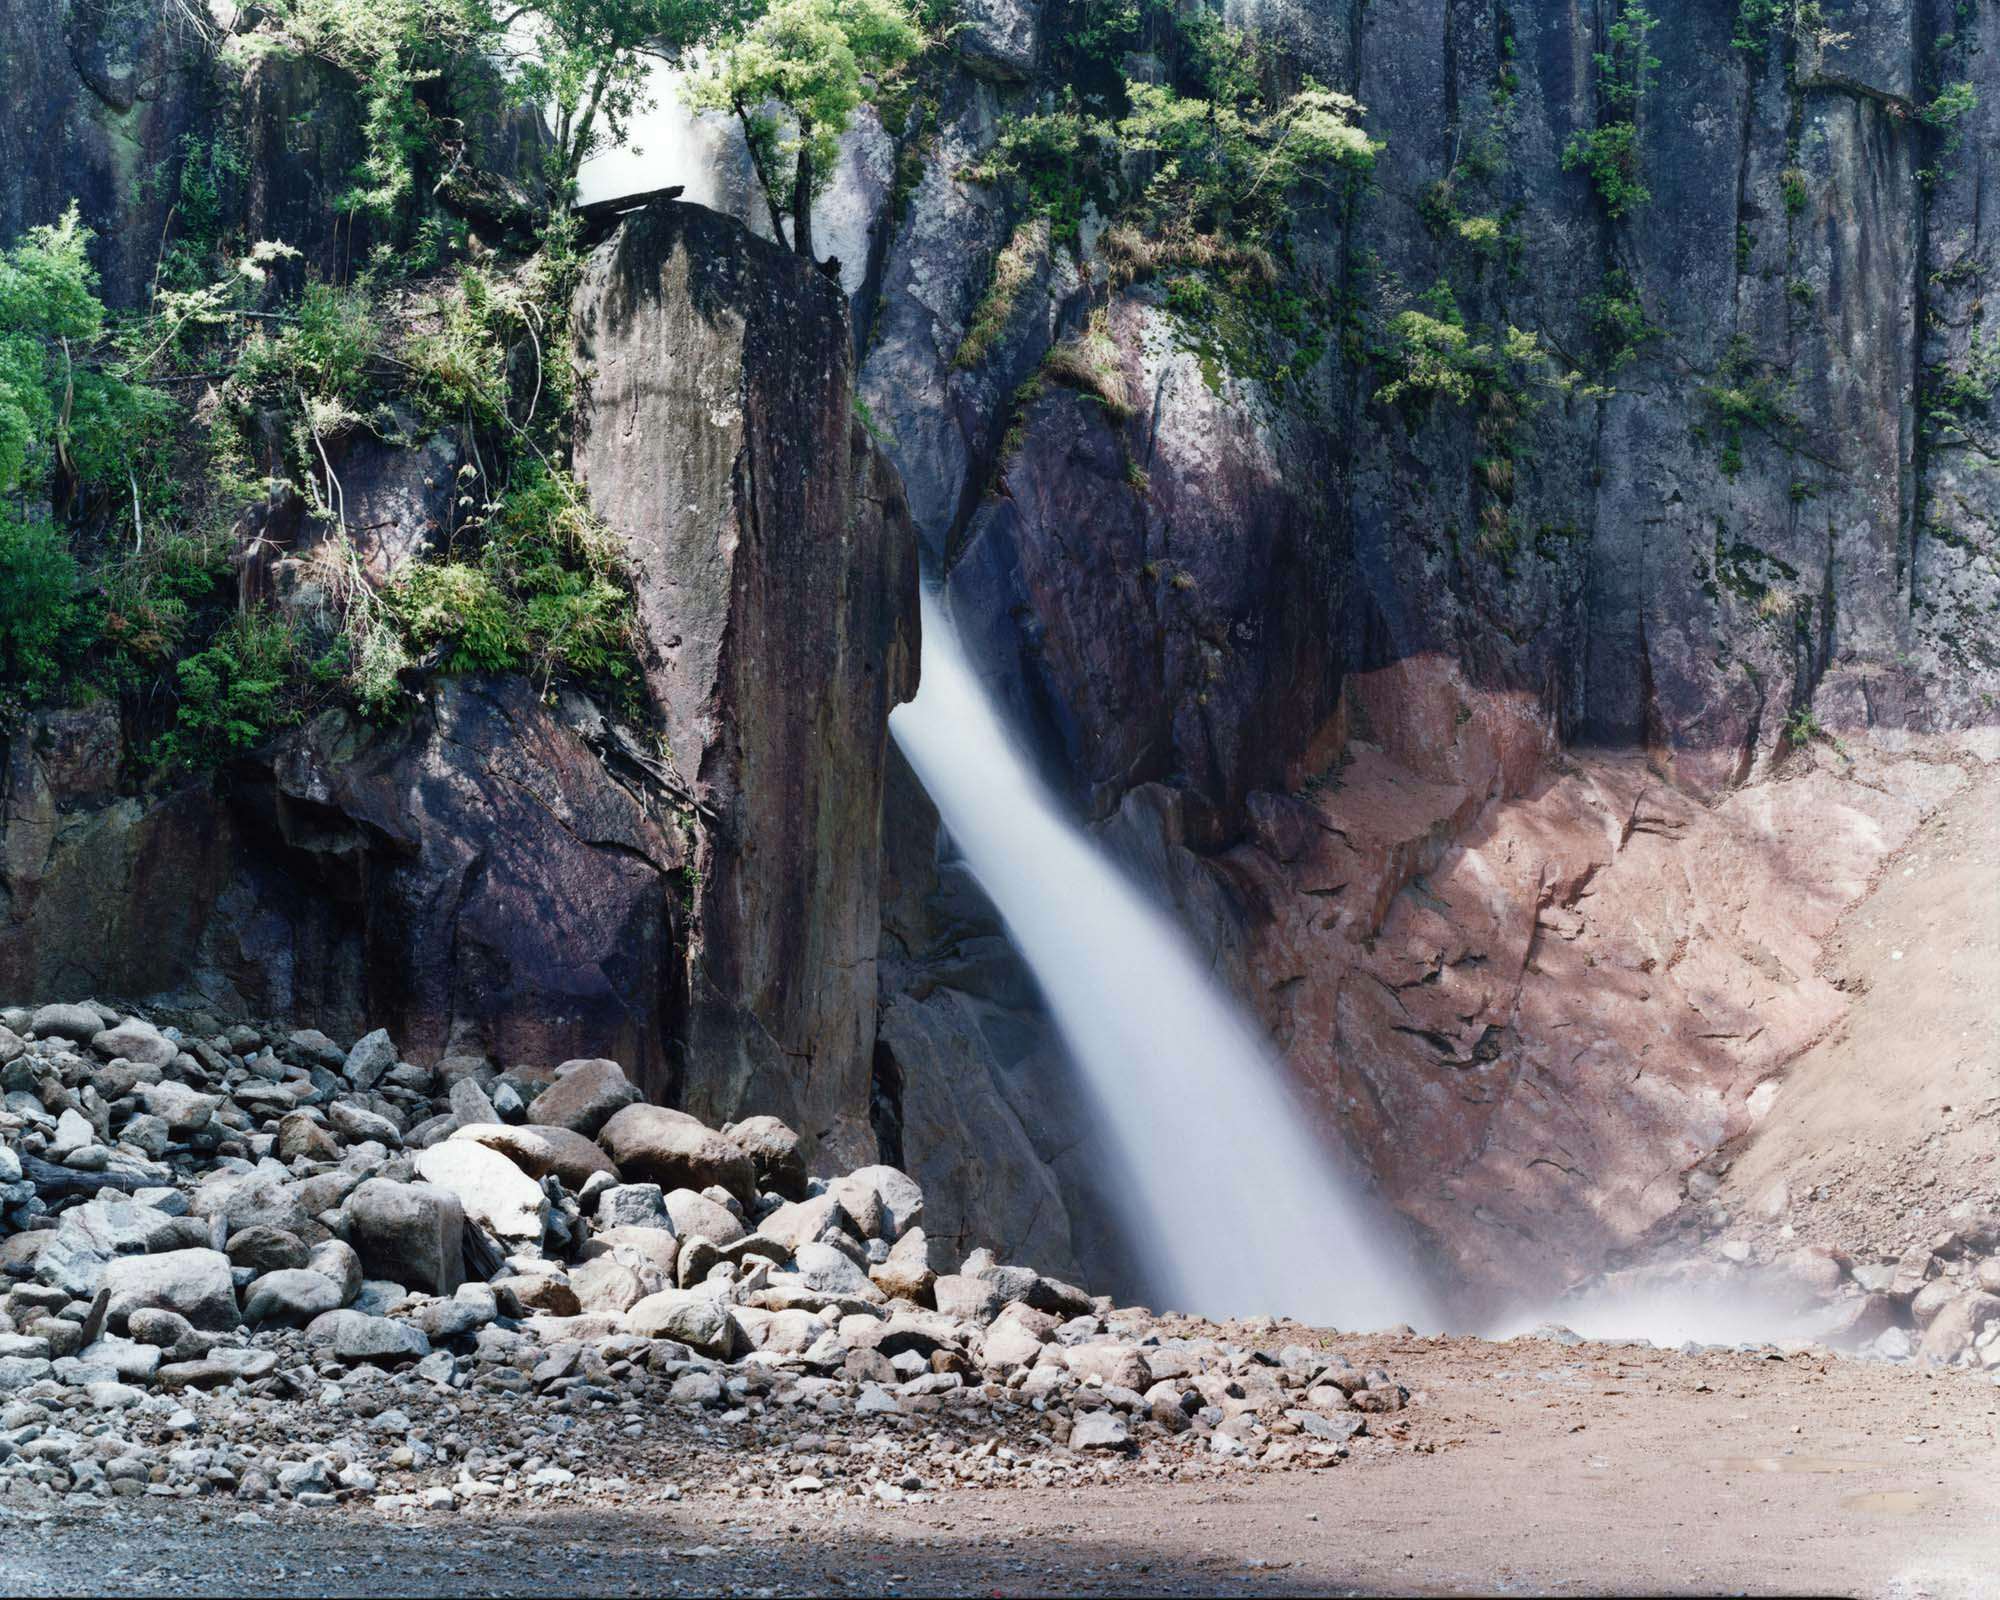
[858,0,2000,1296]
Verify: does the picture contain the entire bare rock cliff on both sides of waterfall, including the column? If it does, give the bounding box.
[0,0,2000,1298]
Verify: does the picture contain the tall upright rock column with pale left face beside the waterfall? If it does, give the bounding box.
[574,204,918,1164]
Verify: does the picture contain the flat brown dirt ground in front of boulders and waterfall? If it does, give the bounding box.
[0,1338,2000,1596]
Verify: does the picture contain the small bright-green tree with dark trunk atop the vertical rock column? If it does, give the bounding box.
[688,0,924,260]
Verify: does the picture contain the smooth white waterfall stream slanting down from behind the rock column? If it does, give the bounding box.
[890,594,1428,1328]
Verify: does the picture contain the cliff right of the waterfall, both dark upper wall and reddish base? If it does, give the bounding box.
[816,0,2000,1290]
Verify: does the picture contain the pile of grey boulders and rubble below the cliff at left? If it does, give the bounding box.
[0,1002,1410,1512]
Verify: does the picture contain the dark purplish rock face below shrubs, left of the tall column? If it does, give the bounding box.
[0,680,686,1072]
